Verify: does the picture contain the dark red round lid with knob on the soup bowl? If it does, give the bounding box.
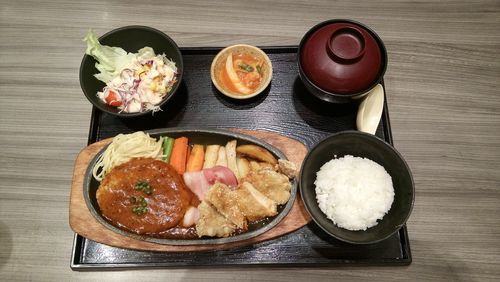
[299,20,387,95]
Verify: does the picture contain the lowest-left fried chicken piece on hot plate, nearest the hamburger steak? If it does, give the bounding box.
[196,201,236,237]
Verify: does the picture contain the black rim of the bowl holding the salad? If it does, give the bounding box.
[79,25,184,118]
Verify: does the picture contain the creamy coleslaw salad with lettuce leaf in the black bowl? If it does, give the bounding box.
[84,30,178,113]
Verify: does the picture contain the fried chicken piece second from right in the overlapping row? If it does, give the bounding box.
[232,182,278,221]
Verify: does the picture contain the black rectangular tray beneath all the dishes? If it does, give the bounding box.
[71,46,412,271]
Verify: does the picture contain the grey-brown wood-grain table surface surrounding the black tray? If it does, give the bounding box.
[0,0,500,281]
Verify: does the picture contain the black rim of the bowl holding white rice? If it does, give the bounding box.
[298,130,415,245]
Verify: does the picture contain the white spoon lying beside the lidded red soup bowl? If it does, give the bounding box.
[356,84,384,134]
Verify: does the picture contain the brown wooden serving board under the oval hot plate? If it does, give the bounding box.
[69,129,311,252]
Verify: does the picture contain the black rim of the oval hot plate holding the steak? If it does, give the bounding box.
[82,127,299,246]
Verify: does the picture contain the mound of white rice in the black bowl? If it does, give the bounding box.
[314,155,394,230]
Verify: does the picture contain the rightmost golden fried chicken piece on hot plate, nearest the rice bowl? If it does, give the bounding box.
[243,169,292,205]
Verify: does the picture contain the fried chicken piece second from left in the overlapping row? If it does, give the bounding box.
[205,182,248,230]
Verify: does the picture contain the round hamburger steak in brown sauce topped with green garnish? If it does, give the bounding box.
[96,158,199,235]
